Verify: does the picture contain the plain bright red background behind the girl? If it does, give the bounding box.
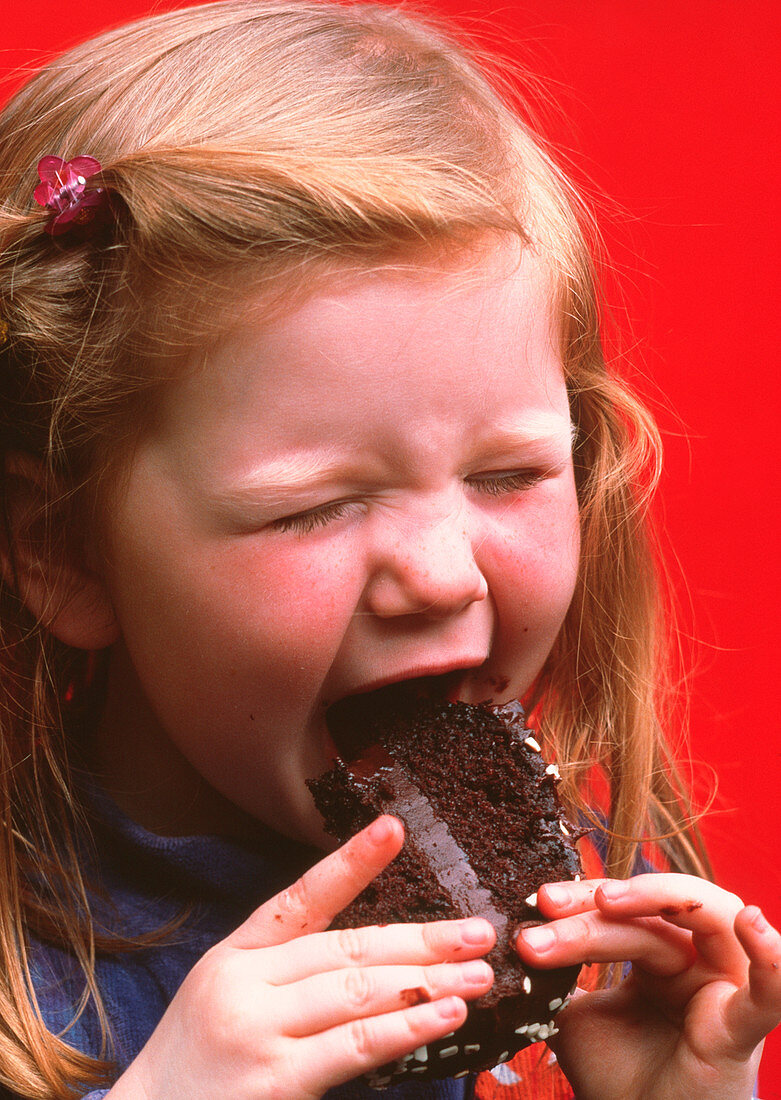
[1,0,781,1100]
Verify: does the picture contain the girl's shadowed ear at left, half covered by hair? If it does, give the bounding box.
[0,453,119,649]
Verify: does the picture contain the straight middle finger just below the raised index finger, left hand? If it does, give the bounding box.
[264,916,496,986]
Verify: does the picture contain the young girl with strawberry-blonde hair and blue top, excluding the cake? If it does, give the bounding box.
[0,0,781,1100]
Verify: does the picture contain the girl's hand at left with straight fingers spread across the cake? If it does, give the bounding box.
[107,816,495,1100]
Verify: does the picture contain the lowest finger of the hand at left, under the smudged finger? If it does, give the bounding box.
[303,997,466,1091]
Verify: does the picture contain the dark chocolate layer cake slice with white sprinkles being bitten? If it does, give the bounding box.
[309,692,581,1088]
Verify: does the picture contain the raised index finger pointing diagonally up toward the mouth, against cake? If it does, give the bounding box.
[228,815,404,948]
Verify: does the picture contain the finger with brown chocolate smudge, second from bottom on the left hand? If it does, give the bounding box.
[276,959,494,1038]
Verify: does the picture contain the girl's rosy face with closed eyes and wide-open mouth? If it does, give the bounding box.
[94,243,579,842]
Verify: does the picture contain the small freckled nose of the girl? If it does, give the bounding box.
[365,501,488,619]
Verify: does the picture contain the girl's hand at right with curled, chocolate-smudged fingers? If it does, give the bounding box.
[518,873,781,1100]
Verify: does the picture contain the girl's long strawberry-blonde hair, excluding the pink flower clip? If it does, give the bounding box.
[0,0,704,1098]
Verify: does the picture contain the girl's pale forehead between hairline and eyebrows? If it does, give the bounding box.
[152,245,561,457]
